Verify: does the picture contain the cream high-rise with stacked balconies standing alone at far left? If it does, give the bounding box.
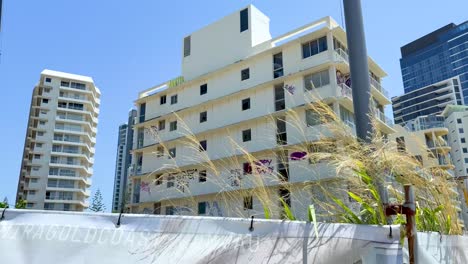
[16,70,100,211]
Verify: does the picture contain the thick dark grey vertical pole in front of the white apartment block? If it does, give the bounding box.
[343,0,372,142]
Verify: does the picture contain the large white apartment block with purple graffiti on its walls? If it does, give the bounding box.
[129,5,394,219]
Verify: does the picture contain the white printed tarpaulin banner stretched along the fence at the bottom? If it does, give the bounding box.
[0,209,450,264]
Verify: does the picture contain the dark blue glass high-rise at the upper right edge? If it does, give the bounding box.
[400,21,468,100]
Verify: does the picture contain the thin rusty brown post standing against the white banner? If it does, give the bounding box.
[403,185,418,264]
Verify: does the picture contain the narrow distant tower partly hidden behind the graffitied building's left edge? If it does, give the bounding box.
[112,109,137,211]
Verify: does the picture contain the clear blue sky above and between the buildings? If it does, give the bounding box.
[0,0,468,210]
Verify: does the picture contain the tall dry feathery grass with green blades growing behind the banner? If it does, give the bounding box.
[133,96,462,234]
